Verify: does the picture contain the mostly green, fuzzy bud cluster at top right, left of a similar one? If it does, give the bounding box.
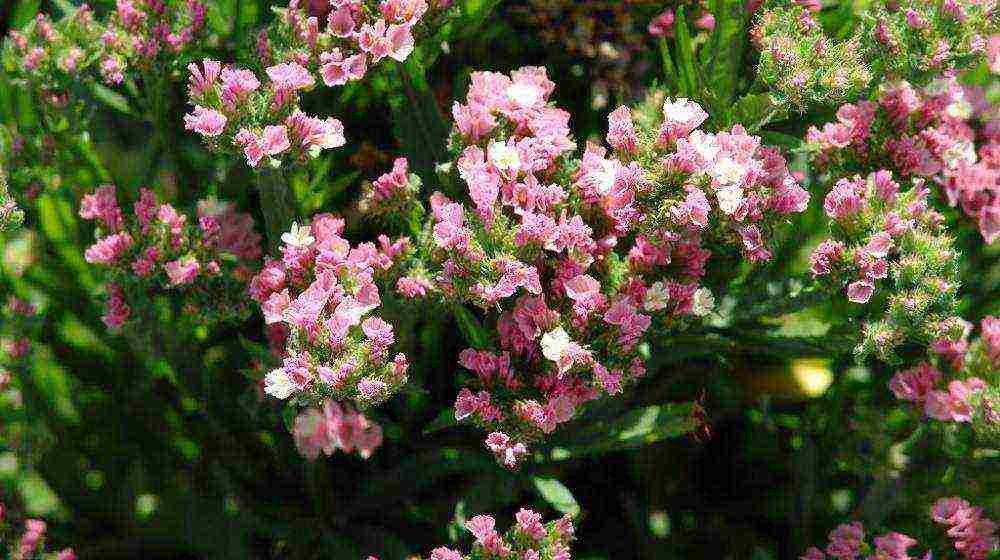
[750,0,872,107]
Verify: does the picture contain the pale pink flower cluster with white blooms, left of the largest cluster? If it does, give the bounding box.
[250,214,409,409]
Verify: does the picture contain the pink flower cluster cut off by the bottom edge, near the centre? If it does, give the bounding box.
[394,508,575,560]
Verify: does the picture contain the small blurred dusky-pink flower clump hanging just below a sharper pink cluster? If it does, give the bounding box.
[292,399,382,460]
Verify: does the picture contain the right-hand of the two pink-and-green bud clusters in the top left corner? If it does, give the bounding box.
[100,0,207,85]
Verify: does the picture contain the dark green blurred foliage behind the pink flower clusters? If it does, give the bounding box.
[0,0,1000,560]
